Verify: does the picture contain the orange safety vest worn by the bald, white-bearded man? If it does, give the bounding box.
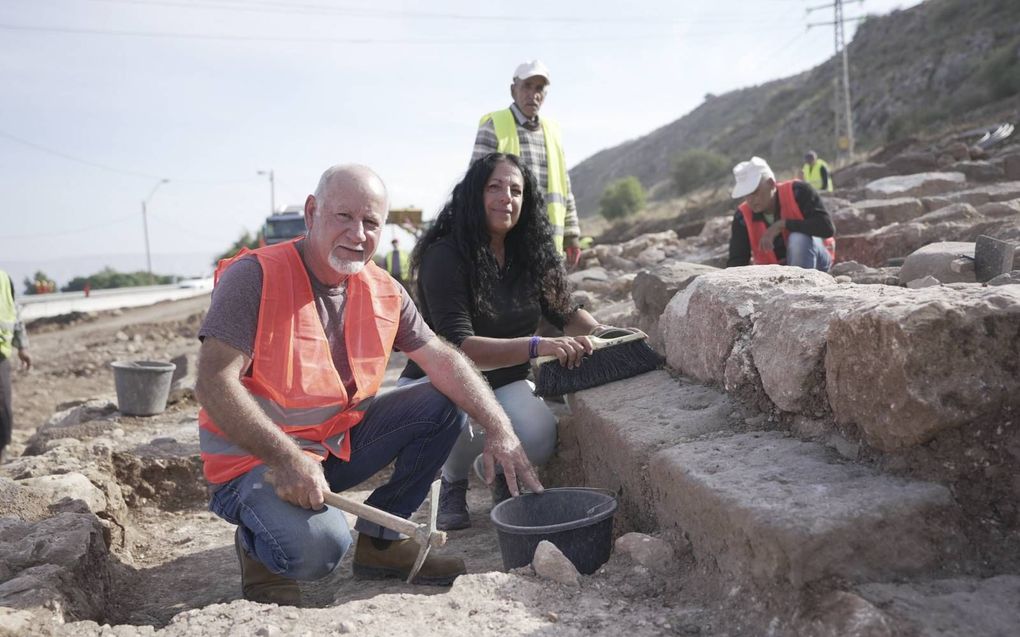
[198,240,403,484]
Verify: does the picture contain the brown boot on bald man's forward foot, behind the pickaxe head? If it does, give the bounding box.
[354,534,467,586]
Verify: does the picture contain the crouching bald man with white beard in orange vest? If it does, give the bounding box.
[195,166,543,605]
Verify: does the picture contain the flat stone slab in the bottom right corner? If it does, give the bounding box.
[859,575,1020,637]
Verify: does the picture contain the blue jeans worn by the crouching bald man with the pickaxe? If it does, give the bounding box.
[209,382,465,580]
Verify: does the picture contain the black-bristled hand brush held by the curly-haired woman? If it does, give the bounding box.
[534,330,664,397]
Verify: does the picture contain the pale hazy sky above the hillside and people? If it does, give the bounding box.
[0,0,917,274]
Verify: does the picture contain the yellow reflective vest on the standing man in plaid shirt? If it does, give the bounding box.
[479,108,567,253]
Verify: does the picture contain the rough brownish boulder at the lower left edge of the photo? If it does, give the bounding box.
[0,513,111,620]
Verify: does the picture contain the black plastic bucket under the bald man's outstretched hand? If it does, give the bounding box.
[490,487,618,575]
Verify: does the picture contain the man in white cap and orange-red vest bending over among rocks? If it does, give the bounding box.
[726,157,835,272]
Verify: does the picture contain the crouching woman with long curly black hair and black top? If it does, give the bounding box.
[401,153,599,530]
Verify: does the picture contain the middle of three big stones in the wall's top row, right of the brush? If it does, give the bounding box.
[751,285,884,416]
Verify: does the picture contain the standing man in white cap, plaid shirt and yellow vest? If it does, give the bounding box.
[471,60,580,268]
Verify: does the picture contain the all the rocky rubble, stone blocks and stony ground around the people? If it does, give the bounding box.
[0,131,1020,637]
